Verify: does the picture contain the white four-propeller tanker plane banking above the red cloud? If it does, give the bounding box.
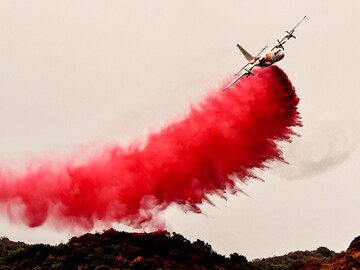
[223,16,306,90]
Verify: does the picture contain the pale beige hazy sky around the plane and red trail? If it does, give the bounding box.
[0,0,360,259]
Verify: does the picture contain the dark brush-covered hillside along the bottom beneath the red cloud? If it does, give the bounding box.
[0,229,360,270]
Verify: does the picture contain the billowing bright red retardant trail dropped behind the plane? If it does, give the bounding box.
[0,66,300,229]
